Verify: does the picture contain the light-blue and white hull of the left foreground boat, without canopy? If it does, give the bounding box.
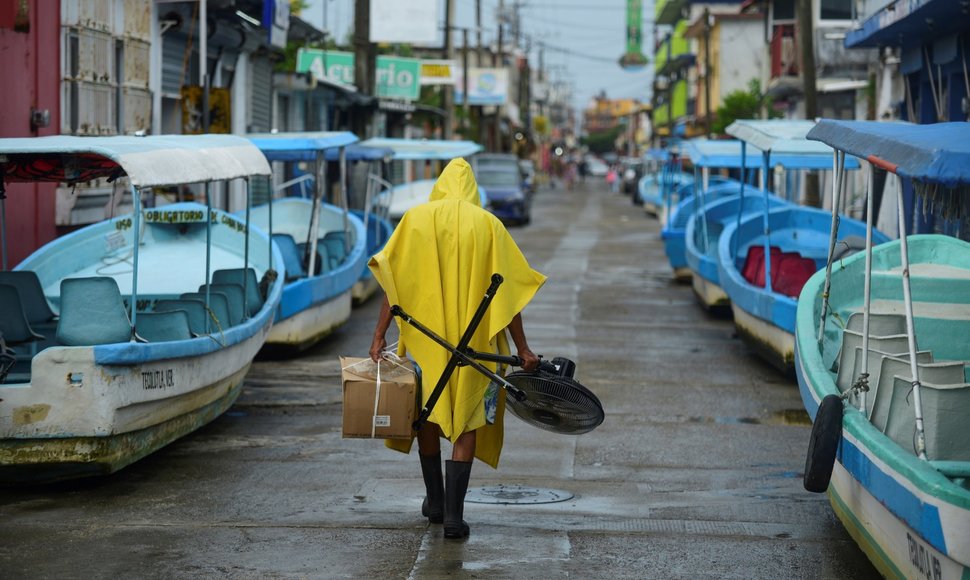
[0,204,282,484]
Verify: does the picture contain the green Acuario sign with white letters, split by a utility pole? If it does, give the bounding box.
[296,48,421,101]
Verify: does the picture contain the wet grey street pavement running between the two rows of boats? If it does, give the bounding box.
[0,182,876,579]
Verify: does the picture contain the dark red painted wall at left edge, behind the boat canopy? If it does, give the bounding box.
[0,0,61,267]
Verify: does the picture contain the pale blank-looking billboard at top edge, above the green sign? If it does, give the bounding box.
[370,0,440,45]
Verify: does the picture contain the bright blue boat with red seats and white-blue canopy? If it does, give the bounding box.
[718,120,888,375]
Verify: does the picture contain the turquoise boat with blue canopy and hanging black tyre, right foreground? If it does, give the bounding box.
[796,120,970,579]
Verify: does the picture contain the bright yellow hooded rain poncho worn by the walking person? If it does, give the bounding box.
[369,159,546,467]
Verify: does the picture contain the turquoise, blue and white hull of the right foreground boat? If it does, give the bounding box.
[796,236,970,578]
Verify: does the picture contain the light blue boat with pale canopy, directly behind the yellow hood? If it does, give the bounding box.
[361,137,488,223]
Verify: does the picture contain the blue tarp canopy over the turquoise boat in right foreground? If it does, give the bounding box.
[808,119,970,187]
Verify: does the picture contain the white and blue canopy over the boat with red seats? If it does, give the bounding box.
[726,119,859,169]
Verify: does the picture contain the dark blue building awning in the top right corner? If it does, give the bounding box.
[845,0,967,48]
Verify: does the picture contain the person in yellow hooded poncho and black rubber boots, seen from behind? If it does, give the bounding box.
[369,159,546,538]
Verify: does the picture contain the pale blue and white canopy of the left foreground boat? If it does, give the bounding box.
[0,134,270,187]
